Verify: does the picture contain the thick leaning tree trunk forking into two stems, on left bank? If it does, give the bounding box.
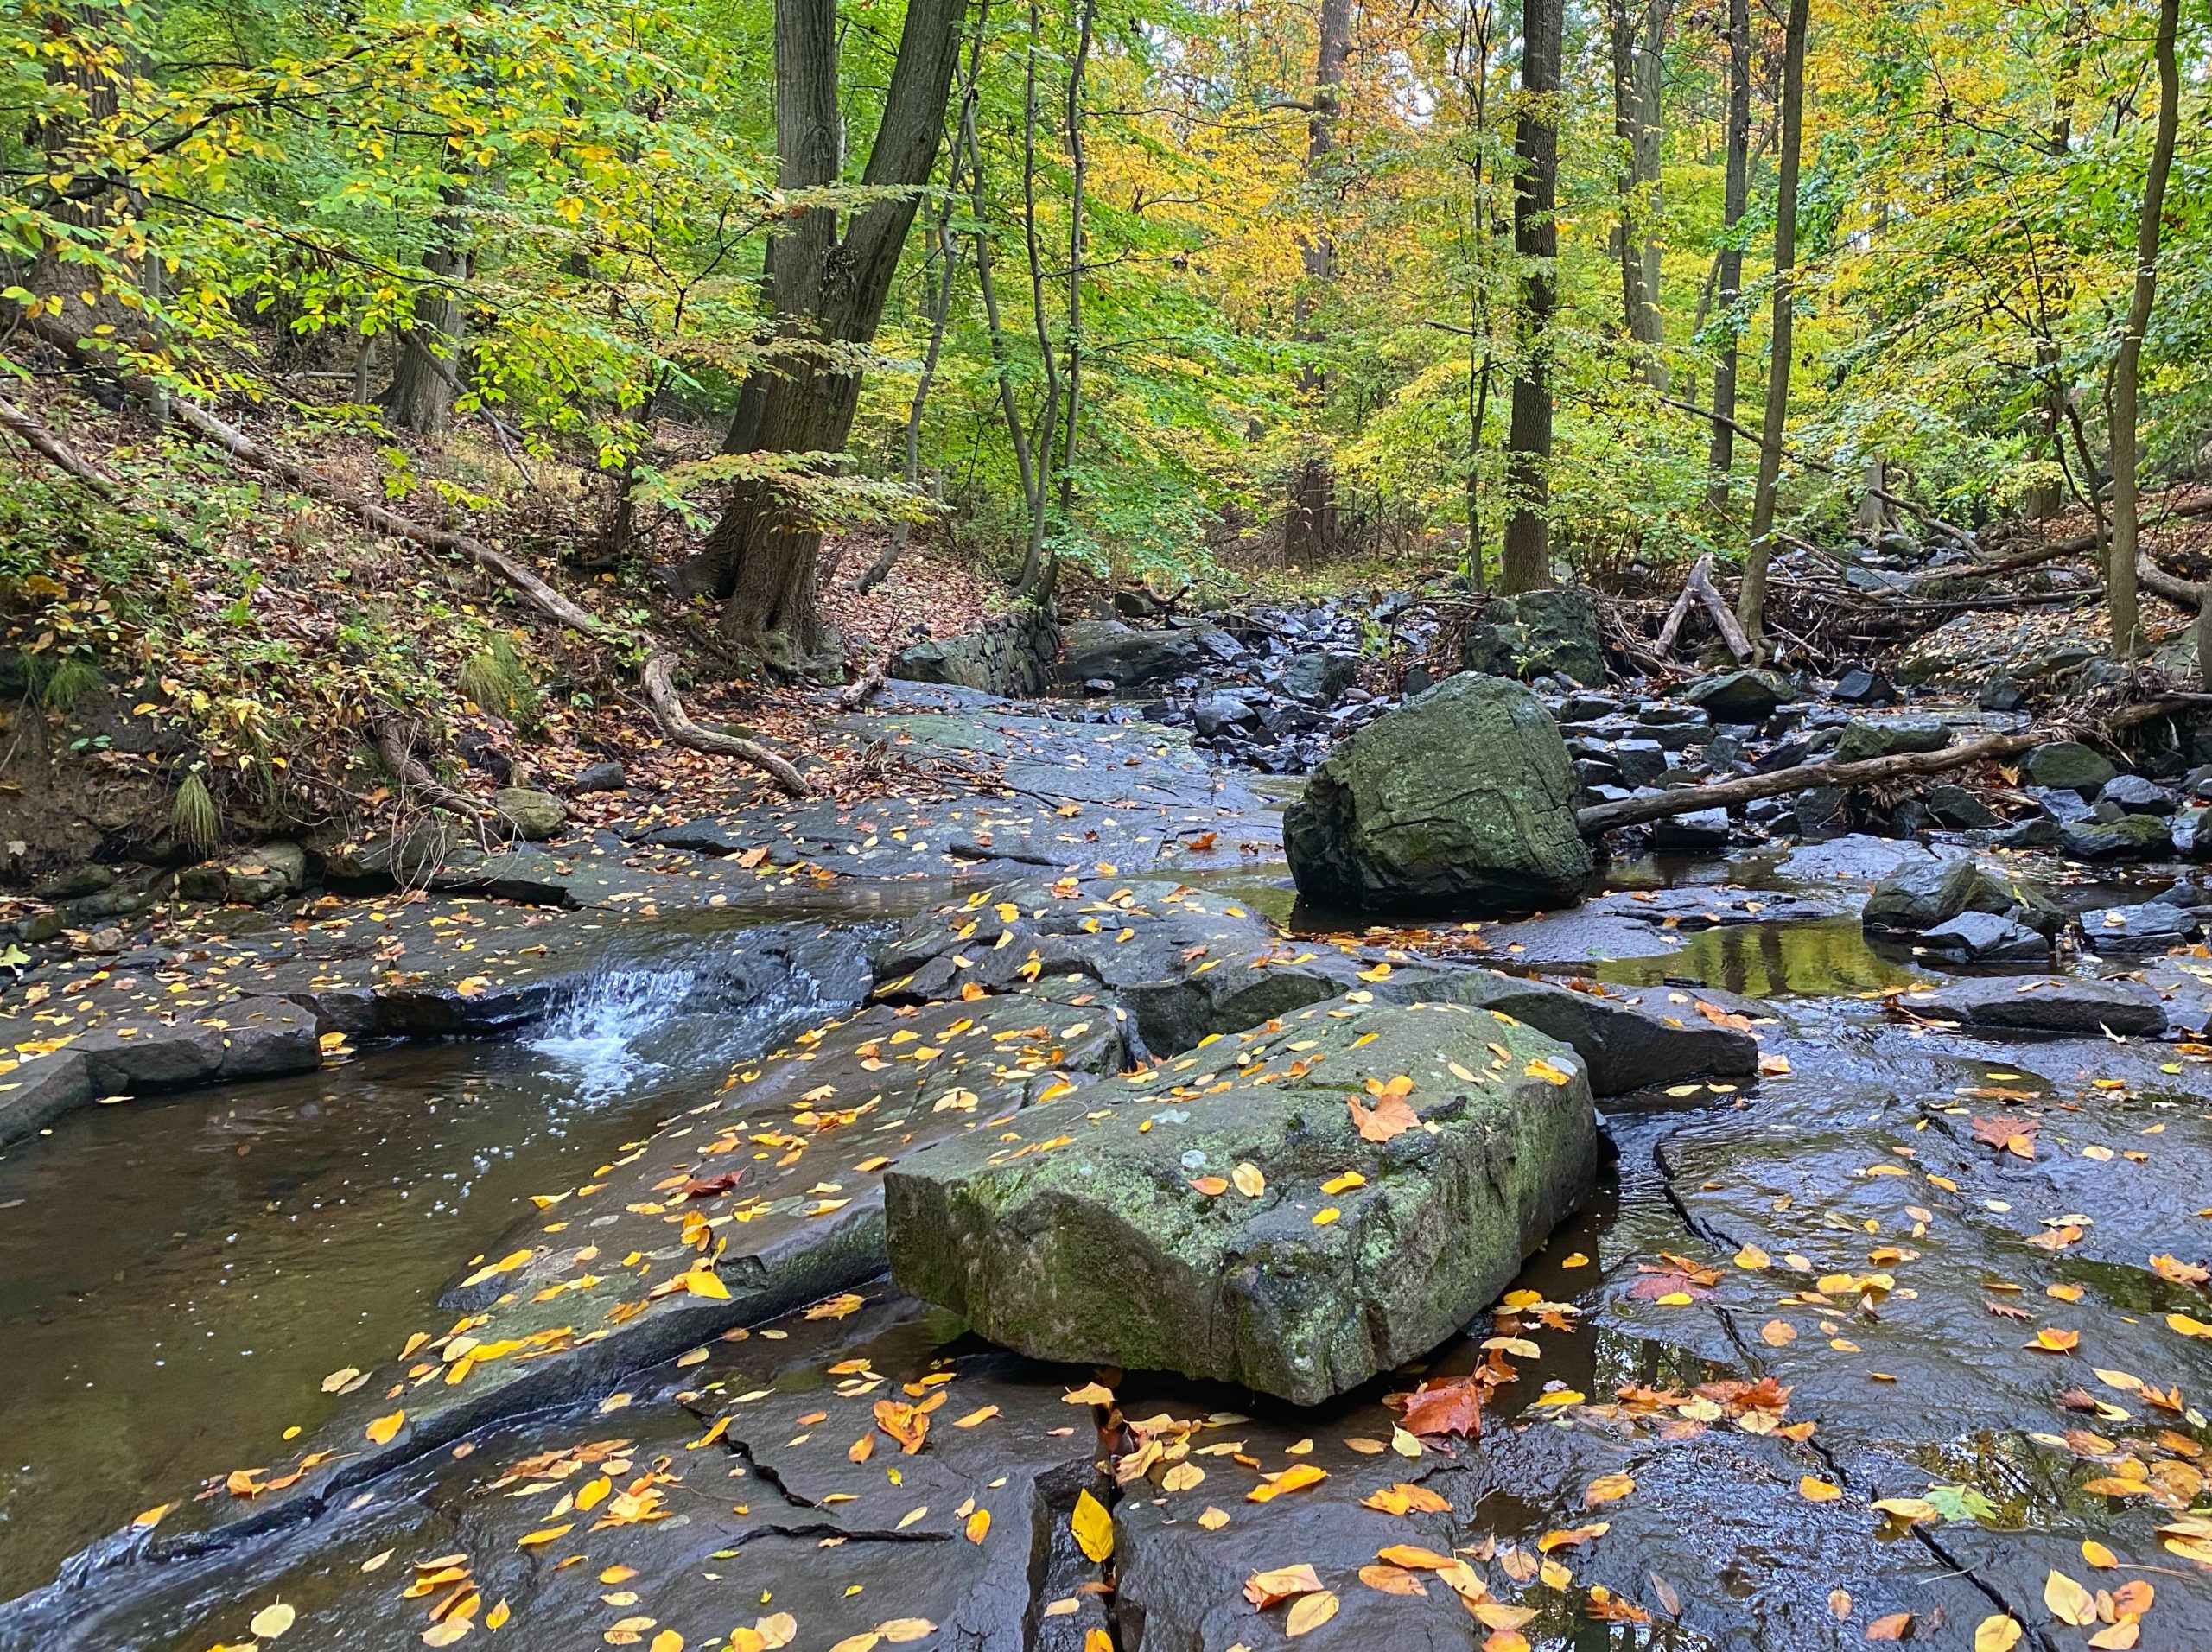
[702,0,964,668]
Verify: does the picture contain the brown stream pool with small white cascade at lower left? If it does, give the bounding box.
[0,933,862,1599]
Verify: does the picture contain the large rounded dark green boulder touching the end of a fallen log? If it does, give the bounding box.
[1283,672,1591,916]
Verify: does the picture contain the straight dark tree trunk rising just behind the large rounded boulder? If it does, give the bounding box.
[1497,0,1574,595]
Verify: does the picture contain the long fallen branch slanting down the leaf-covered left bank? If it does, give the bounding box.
[19,316,807,807]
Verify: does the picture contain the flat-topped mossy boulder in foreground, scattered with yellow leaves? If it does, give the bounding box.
[885,997,1597,1404]
